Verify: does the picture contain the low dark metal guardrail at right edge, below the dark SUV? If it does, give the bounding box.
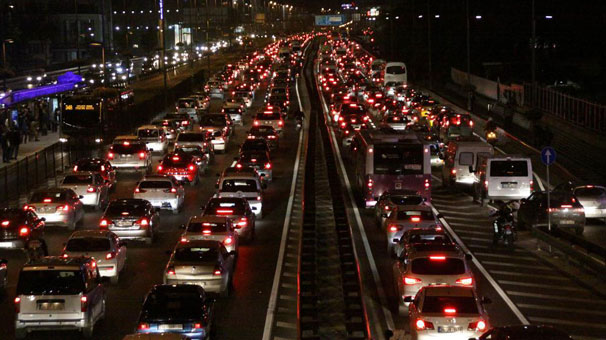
[531,227,606,277]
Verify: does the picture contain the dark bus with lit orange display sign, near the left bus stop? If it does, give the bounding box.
[60,88,133,144]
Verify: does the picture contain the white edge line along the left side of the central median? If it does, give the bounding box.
[263,65,307,340]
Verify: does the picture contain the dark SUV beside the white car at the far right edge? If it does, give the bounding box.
[517,191,585,235]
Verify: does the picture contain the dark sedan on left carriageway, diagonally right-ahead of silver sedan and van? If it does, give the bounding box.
[99,198,160,245]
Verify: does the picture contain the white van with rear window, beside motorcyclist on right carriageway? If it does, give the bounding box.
[473,156,534,205]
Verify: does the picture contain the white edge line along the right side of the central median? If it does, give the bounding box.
[314,59,395,337]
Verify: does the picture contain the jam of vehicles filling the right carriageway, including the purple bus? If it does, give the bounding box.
[315,34,605,339]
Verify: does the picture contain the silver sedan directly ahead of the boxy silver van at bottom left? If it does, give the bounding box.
[62,229,126,284]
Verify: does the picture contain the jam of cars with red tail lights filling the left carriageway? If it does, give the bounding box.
[0,35,311,339]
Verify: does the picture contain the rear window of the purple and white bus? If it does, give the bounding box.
[373,144,423,175]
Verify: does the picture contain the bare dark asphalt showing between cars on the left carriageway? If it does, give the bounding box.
[0,70,298,339]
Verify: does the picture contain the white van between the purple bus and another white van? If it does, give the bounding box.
[442,137,494,187]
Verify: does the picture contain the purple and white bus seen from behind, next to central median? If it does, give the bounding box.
[350,128,431,208]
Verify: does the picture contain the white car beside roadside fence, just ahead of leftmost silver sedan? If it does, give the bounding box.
[59,171,109,210]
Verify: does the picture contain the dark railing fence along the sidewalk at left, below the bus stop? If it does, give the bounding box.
[0,143,90,207]
